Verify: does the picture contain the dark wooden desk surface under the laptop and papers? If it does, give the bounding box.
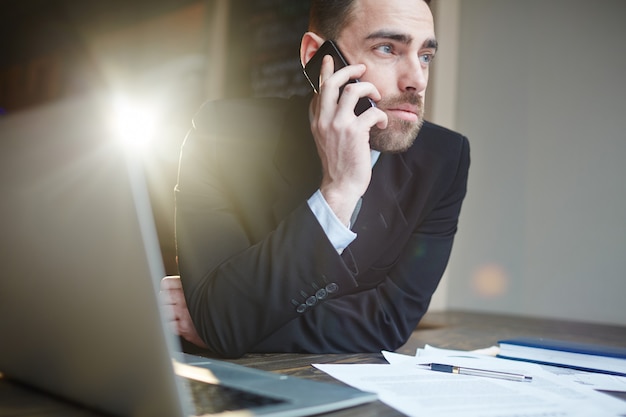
[0,311,626,417]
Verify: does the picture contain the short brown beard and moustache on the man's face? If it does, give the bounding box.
[370,93,424,152]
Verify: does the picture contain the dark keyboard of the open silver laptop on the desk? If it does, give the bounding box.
[183,378,285,415]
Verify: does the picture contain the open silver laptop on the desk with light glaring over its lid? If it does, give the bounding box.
[0,98,376,417]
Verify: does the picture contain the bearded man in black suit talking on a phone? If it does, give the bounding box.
[162,0,469,357]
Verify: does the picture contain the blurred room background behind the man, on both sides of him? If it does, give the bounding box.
[0,0,626,324]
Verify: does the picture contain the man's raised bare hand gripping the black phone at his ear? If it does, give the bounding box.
[307,41,387,225]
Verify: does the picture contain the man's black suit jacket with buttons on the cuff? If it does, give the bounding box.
[176,98,469,357]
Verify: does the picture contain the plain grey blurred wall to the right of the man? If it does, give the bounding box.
[434,0,626,324]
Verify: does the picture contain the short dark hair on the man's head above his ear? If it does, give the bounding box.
[309,0,430,39]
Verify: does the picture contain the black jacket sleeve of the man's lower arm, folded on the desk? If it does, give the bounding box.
[249,137,470,353]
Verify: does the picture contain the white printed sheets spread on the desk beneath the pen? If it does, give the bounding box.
[314,346,626,417]
